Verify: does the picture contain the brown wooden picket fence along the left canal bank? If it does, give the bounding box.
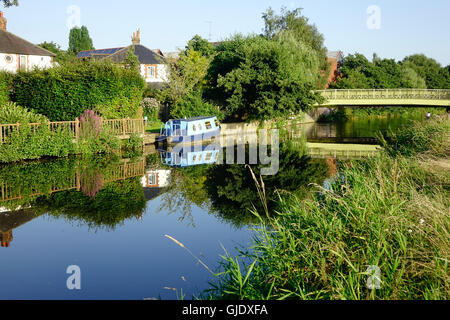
[0,118,145,143]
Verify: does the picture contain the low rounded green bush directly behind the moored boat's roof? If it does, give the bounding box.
[170,93,224,120]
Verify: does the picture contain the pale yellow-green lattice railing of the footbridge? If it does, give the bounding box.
[315,89,450,101]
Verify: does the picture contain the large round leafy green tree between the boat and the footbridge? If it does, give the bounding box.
[207,34,320,119]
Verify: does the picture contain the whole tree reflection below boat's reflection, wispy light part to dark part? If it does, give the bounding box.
[160,141,329,228]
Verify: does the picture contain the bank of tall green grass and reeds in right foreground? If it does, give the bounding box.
[205,118,450,299]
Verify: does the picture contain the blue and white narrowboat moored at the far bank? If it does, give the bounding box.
[158,117,220,143]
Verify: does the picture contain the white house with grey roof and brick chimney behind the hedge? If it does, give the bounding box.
[78,30,168,87]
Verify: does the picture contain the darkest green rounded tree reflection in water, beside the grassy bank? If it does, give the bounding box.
[205,141,330,227]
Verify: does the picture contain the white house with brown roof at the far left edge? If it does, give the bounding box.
[0,12,55,73]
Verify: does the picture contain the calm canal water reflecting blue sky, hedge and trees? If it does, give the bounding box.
[0,118,426,299]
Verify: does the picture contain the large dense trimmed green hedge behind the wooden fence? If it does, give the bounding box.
[13,61,145,121]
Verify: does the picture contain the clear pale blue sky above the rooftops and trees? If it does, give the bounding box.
[3,0,450,65]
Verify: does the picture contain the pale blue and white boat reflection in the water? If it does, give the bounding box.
[158,143,221,168]
